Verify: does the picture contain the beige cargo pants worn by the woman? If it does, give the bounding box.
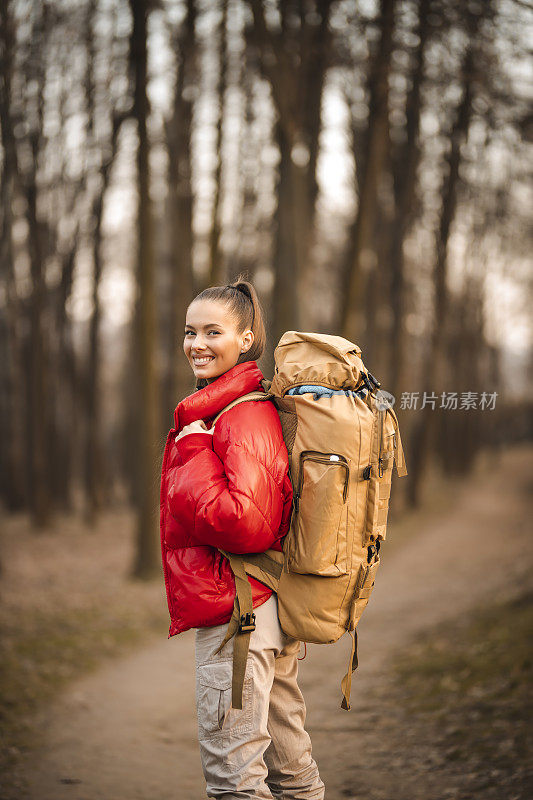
[196,594,324,800]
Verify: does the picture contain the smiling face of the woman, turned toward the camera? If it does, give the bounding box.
[183,300,254,381]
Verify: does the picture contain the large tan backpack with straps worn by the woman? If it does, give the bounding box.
[210,331,407,710]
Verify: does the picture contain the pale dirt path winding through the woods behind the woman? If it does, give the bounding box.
[14,448,533,800]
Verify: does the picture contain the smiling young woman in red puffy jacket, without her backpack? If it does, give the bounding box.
[161,280,324,800]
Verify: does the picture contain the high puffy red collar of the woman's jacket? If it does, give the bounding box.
[174,361,263,431]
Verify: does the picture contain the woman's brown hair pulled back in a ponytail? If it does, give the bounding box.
[192,273,266,389]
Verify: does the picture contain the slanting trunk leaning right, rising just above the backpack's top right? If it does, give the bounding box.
[341,0,395,341]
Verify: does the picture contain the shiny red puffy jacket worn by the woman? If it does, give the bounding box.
[161,361,292,637]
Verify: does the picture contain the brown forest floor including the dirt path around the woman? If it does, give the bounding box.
[0,446,533,800]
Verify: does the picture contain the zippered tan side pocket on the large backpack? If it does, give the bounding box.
[287,450,350,577]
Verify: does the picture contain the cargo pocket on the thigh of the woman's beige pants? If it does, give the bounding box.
[196,661,253,739]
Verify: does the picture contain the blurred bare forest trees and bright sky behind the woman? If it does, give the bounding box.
[0,0,533,575]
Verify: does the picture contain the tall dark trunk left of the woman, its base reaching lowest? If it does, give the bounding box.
[130,0,159,578]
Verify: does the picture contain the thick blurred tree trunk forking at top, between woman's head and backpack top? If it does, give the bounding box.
[249,0,332,340]
